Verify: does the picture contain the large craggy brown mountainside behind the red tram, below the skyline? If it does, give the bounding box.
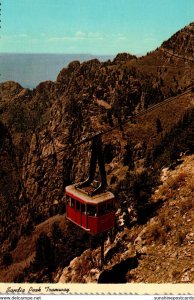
[0,23,194,278]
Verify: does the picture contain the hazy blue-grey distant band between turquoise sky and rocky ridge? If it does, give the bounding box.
[0,53,114,89]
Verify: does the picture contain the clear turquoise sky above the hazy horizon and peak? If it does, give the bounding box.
[0,0,194,55]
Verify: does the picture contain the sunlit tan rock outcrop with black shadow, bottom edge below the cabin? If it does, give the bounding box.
[59,233,138,283]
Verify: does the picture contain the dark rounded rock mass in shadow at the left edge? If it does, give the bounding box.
[0,122,25,250]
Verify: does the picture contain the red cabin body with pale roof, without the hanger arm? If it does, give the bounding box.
[66,185,115,234]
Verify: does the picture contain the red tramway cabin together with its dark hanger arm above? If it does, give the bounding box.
[65,134,115,234]
